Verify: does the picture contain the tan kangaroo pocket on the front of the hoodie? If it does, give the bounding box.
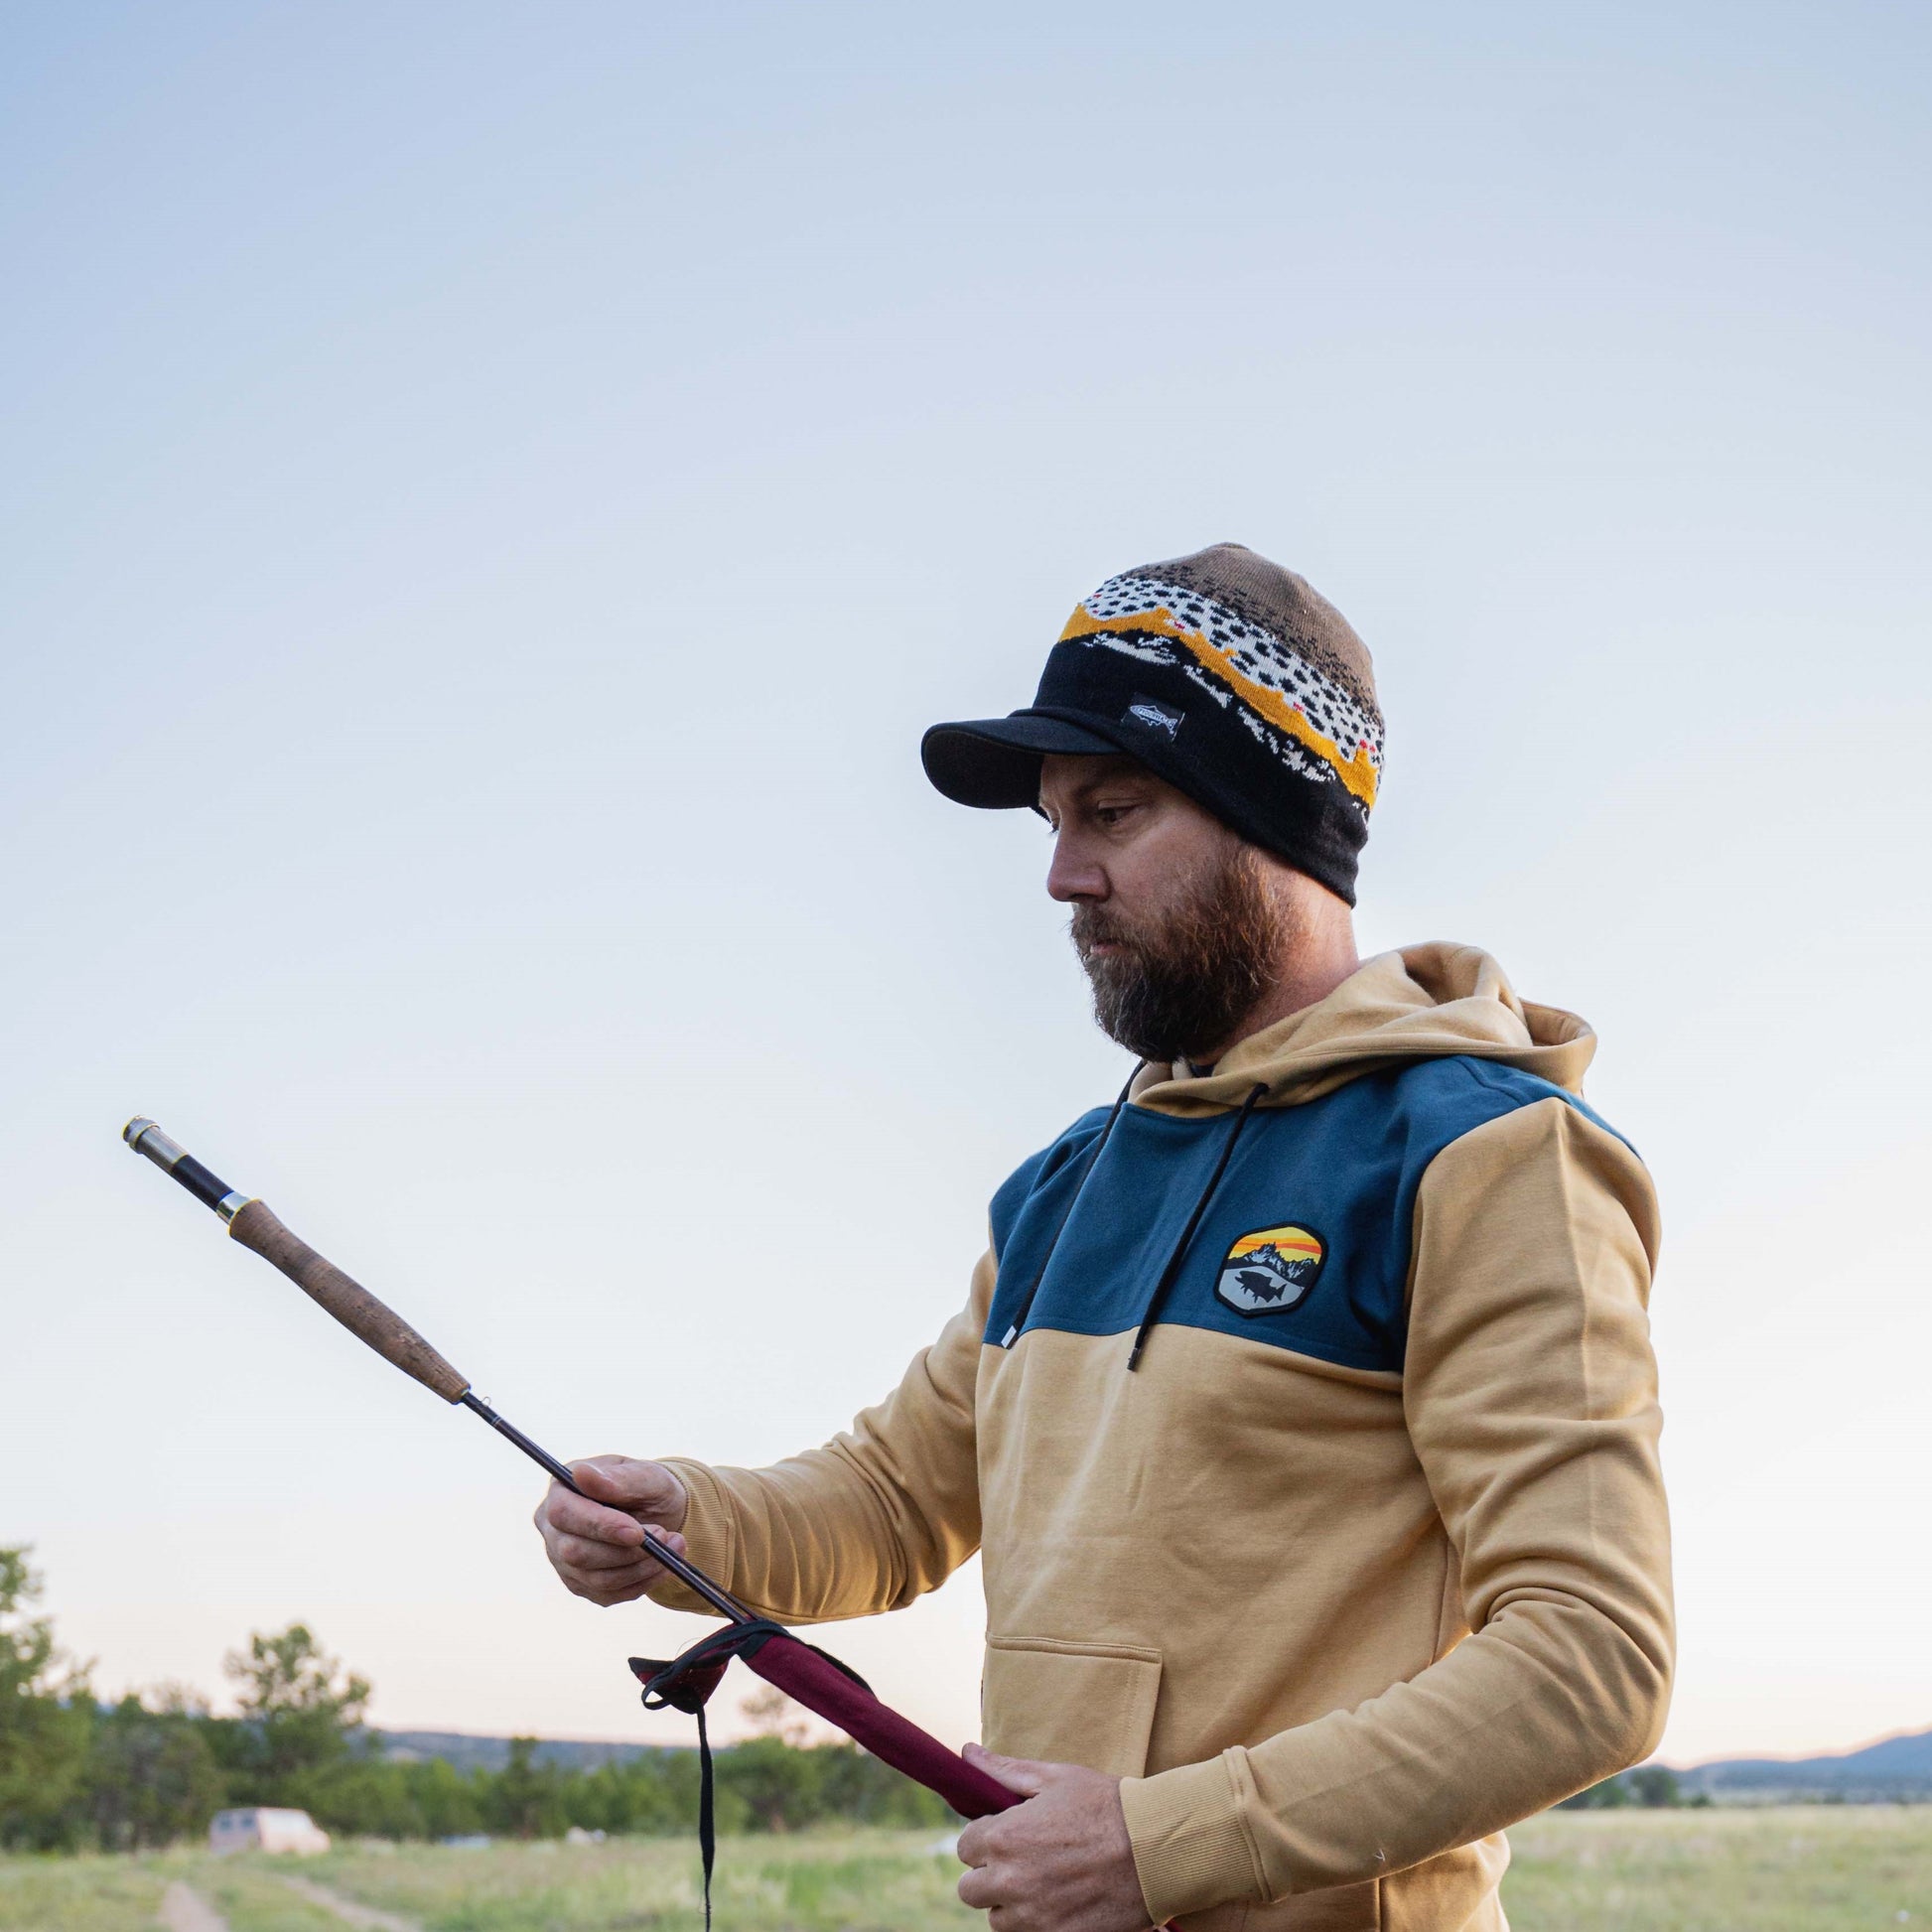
[980,1636,1162,1777]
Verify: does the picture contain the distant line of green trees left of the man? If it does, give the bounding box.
[0,1550,950,1851]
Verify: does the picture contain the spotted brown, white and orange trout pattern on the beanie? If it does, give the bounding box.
[1060,560,1381,827]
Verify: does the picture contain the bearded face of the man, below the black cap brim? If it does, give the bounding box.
[1039,758,1289,1060]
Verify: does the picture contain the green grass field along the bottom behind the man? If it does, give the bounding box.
[0,1807,1932,1932]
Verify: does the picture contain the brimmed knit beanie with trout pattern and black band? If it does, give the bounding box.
[919,543,1381,906]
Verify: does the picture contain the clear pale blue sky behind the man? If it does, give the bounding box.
[0,0,1932,1758]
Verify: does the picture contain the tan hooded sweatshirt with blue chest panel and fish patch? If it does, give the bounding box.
[653,945,1673,1932]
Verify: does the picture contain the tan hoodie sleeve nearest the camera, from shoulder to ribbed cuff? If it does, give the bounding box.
[1123,1099,1673,1924]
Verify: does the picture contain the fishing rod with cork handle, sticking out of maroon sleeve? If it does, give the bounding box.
[122,1115,758,1625]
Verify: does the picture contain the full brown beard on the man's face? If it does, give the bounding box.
[1070,844,1287,1060]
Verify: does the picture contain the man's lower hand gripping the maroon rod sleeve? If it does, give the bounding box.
[960,1744,1148,1932]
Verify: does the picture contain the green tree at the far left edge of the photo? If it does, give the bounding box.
[0,1546,92,1849]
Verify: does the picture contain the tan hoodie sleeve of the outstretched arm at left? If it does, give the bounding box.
[651,1254,995,1623]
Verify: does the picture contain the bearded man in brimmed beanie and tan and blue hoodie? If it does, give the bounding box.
[537,545,1671,1932]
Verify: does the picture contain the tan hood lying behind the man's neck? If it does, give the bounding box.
[1132,941,1595,1117]
